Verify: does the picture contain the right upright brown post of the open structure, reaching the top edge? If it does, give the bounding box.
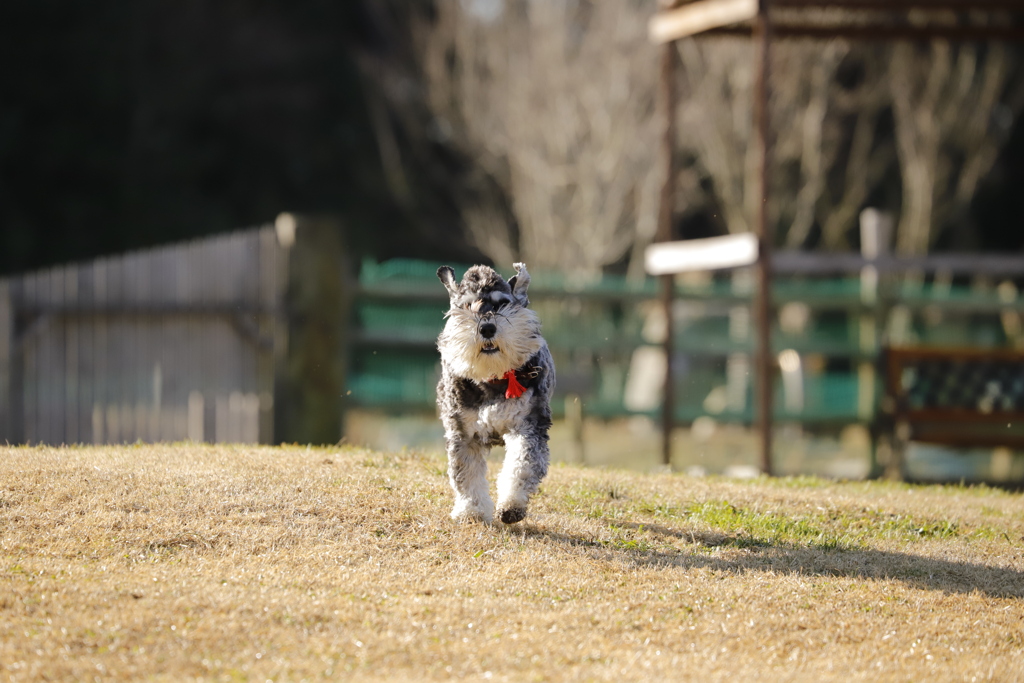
[754,0,774,475]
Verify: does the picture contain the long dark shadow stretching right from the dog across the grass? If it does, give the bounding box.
[522,522,1024,598]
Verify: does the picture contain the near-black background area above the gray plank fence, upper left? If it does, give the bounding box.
[0,0,487,272]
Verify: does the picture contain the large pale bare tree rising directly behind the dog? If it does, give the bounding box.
[416,0,657,275]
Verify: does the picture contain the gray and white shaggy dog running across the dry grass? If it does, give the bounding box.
[437,263,555,524]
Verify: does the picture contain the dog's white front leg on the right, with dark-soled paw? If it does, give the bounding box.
[498,428,550,524]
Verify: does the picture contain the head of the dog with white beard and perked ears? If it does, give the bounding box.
[437,263,544,382]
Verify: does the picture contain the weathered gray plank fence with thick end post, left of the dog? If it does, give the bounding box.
[0,216,352,444]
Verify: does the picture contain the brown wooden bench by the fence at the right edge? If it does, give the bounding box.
[879,347,1024,478]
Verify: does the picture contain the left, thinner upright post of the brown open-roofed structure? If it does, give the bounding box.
[657,41,676,465]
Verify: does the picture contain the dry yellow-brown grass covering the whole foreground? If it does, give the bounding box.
[0,444,1024,681]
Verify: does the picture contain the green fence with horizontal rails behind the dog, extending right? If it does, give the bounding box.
[347,259,1024,424]
